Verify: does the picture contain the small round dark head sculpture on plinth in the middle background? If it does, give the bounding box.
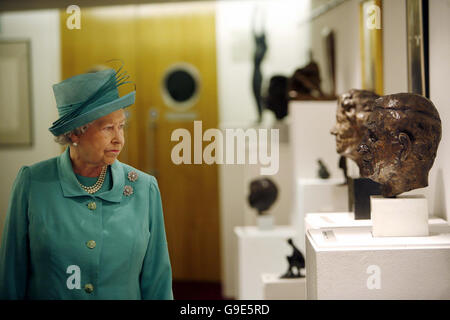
[248,178,278,215]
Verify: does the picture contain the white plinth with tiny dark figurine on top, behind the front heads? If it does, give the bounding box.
[292,179,348,252]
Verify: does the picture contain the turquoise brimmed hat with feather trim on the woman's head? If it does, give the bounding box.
[49,67,136,136]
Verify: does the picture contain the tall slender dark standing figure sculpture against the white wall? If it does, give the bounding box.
[252,12,267,123]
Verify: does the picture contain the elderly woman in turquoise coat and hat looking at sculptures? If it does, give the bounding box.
[0,69,173,299]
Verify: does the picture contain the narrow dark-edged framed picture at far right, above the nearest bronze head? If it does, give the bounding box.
[406,0,430,97]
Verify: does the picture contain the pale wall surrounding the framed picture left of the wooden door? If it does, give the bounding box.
[0,10,60,236]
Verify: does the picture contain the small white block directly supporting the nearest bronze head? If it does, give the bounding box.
[370,195,428,237]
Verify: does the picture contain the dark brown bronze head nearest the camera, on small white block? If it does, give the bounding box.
[358,93,442,197]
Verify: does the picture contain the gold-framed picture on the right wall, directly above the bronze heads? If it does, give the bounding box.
[359,0,383,95]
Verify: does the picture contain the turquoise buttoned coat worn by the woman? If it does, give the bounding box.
[0,148,173,299]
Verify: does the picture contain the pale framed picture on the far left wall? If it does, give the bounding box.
[0,40,32,147]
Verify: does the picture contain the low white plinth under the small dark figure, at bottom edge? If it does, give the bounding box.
[261,273,306,300]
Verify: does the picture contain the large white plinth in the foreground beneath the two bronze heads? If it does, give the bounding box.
[306,224,450,300]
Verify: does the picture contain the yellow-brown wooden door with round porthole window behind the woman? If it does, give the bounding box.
[61,4,221,282]
